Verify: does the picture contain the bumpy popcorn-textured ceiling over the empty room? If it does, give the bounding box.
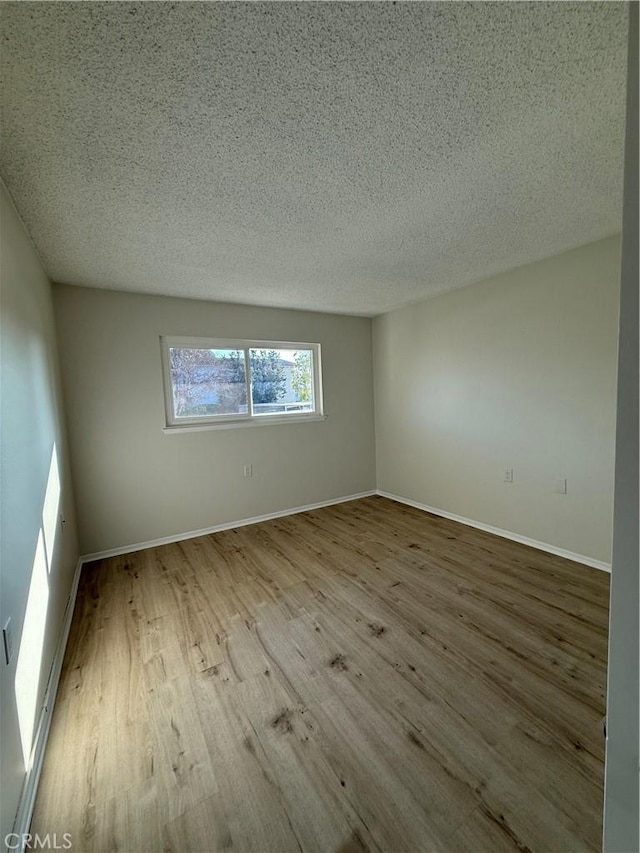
[0,2,627,315]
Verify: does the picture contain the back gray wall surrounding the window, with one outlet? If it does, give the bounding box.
[54,286,375,554]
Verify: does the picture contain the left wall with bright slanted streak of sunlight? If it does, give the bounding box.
[0,185,78,838]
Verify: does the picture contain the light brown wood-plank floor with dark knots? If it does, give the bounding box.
[31,497,609,853]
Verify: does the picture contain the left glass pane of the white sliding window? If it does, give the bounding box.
[169,347,247,418]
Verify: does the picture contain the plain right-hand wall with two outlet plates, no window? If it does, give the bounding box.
[374,237,620,563]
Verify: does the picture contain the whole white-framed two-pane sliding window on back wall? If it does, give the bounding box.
[160,338,322,429]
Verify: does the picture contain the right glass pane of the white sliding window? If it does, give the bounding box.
[249,349,315,415]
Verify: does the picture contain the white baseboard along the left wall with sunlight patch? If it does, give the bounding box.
[12,557,82,851]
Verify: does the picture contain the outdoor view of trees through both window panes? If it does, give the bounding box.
[169,347,314,418]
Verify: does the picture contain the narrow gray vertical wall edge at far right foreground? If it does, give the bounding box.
[604,3,640,853]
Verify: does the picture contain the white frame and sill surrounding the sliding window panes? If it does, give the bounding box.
[160,335,326,432]
